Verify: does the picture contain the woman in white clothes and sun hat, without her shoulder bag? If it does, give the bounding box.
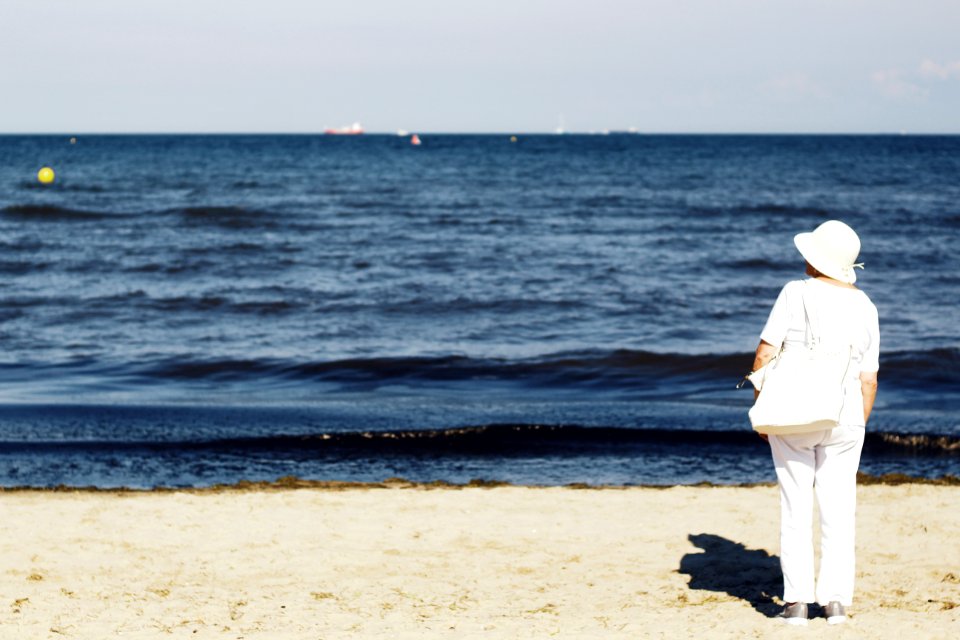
[753,220,880,625]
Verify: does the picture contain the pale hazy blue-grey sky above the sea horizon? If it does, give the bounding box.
[0,0,960,133]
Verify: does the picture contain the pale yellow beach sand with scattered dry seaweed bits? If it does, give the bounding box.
[0,484,960,639]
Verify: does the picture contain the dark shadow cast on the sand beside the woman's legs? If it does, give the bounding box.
[678,533,783,617]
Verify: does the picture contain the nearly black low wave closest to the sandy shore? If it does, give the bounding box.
[0,424,960,457]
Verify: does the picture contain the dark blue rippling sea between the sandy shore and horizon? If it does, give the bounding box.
[0,134,960,488]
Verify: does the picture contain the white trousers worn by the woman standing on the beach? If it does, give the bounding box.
[770,425,865,606]
